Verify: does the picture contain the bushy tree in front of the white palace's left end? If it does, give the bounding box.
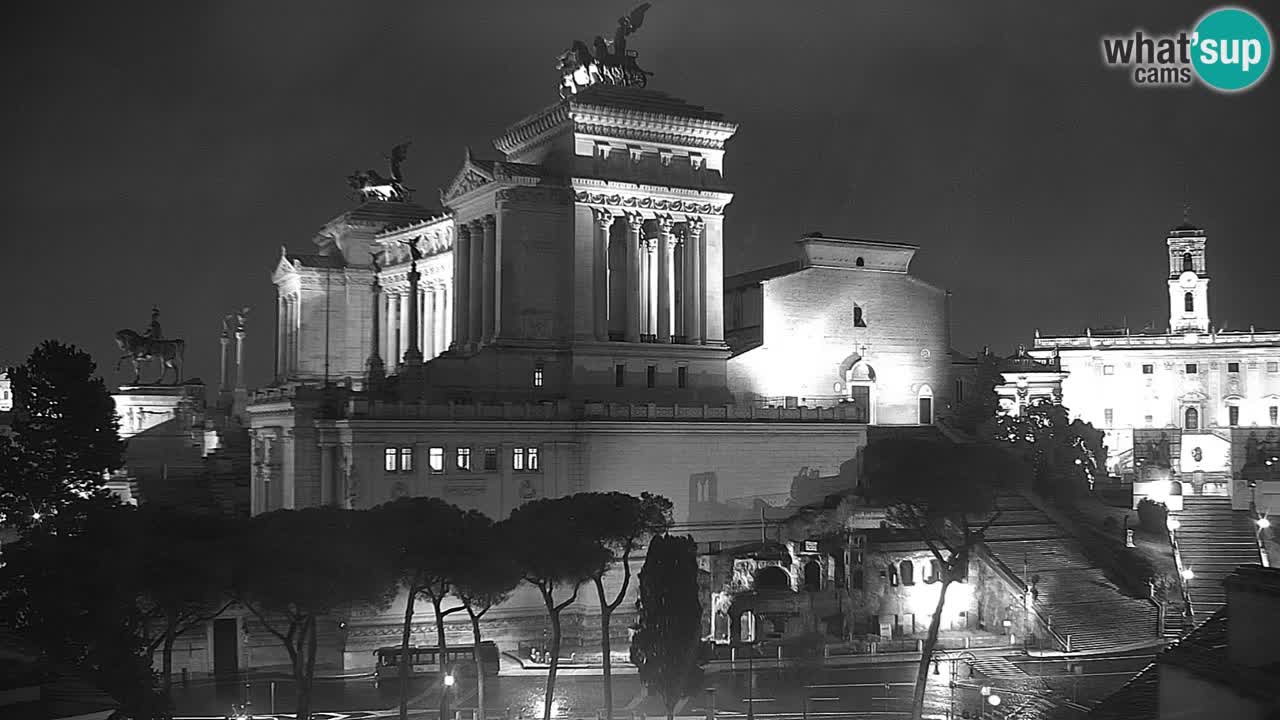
[992,400,1107,497]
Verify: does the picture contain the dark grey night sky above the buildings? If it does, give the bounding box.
[0,0,1280,386]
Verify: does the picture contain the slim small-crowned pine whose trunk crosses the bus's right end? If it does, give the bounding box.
[453,514,521,720]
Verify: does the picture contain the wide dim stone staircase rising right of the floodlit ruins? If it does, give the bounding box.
[986,492,1160,652]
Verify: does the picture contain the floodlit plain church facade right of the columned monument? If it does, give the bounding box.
[727,238,952,424]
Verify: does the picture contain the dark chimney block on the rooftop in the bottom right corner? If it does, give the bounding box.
[1224,565,1280,667]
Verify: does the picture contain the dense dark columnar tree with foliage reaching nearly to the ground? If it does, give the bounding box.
[631,534,703,720]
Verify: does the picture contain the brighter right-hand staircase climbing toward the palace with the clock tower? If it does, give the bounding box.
[1172,495,1262,625]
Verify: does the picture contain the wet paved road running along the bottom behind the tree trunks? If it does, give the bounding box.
[175,653,1151,720]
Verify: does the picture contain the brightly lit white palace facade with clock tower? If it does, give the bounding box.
[1030,223,1280,510]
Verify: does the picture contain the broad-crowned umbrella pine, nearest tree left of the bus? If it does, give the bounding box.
[234,507,397,720]
